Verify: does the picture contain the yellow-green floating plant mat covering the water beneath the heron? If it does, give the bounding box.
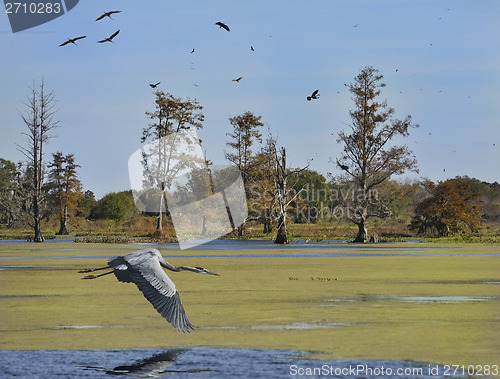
[0,242,500,364]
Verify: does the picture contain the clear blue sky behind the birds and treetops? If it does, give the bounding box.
[0,0,500,197]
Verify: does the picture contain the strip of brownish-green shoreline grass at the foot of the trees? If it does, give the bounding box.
[0,216,500,244]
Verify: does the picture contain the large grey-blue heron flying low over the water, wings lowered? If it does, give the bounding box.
[78,249,219,333]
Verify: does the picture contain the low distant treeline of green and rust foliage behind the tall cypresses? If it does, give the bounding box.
[0,158,500,239]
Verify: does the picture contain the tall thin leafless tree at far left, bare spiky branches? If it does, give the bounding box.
[17,79,59,242]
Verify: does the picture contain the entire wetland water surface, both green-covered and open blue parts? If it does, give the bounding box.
[0,241,500,378]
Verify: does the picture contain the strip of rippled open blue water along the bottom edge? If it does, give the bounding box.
[0,347,463,379]
